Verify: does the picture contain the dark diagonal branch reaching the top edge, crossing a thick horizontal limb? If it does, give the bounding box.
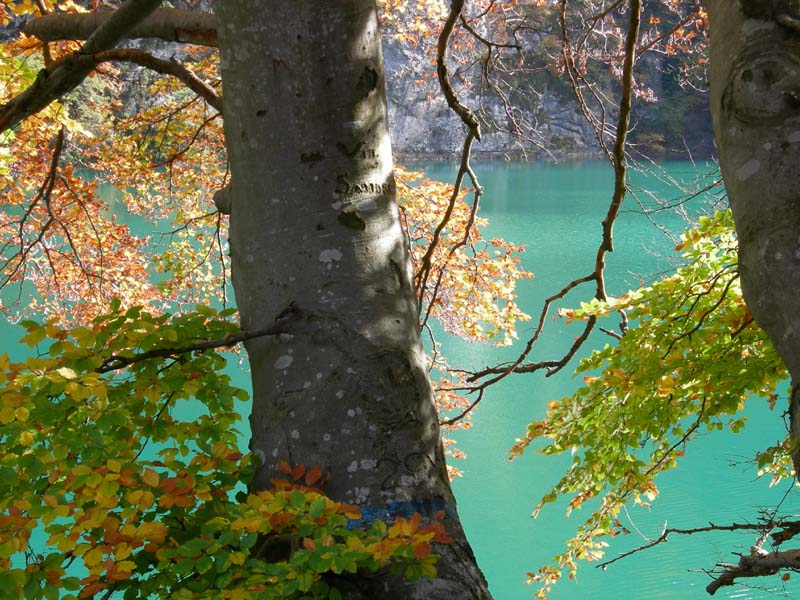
[0,0,166,132]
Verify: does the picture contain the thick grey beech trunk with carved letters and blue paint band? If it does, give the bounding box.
[212,0,489,600]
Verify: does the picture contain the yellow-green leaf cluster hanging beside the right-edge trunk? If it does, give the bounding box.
[512,211,786,594]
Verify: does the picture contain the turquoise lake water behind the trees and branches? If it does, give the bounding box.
[0,163,800,600]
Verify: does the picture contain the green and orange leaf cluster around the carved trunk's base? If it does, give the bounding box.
[0,302,448,600]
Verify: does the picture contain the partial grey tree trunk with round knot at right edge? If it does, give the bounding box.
[706,0,800,474]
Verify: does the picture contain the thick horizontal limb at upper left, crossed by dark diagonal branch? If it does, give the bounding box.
[23,8,217,46]
